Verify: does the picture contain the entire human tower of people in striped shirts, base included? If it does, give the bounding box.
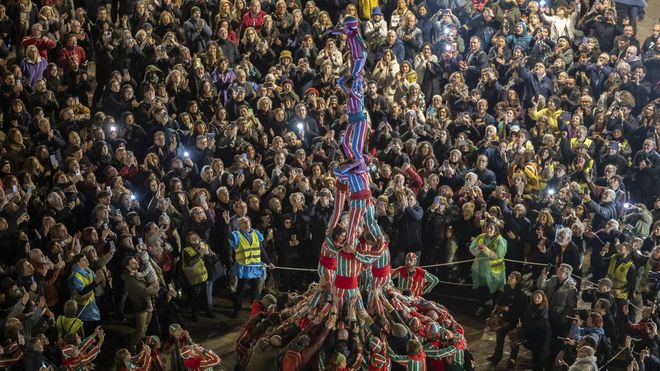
[237,16,467,371]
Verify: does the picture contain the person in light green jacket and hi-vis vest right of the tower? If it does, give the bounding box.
[470,223,507,316]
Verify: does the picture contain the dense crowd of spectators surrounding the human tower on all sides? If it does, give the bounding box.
[0,0,660,370]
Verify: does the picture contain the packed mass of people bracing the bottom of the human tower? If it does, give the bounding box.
[237,276,472,371]
